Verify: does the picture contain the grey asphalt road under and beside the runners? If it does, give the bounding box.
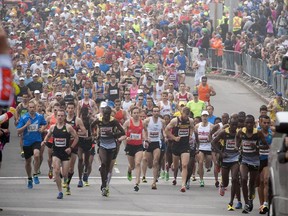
[0,78,263,216]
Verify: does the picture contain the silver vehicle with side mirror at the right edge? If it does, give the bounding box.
[269,112,288,216]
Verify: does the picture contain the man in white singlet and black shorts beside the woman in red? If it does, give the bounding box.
[142,107,166,190]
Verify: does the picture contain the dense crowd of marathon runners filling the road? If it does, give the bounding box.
[0,0,287,214]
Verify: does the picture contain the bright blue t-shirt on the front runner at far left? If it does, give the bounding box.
[17,113,47,146]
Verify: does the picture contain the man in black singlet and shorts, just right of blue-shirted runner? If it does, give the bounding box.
[42,110,78,199]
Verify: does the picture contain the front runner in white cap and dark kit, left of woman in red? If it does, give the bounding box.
[91,106,125,196]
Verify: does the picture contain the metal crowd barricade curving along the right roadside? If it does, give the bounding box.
[187,46,288,100]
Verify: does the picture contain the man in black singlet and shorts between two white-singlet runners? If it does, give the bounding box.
[165,107,194,192]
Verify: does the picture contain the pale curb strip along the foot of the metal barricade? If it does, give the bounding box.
[187,73,270,104]
